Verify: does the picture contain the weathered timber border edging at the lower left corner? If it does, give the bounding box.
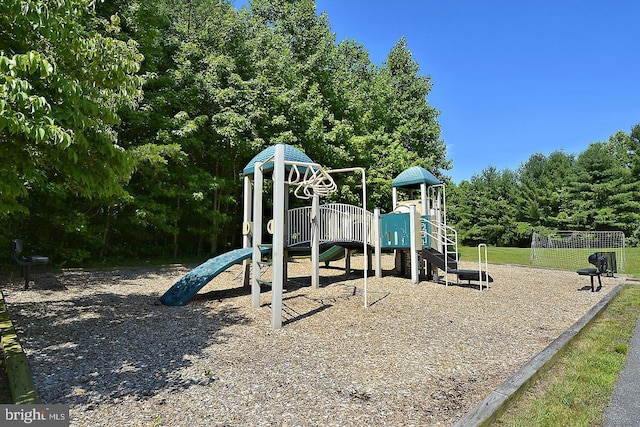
[0,291,41,404]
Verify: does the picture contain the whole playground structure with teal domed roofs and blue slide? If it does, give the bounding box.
[160,144,493,329]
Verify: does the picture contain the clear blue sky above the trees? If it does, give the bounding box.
[236,0,640,182]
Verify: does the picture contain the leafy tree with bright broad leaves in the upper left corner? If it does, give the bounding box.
[0,0,142,216]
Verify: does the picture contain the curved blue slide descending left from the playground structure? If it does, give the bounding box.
[160,248,262,306]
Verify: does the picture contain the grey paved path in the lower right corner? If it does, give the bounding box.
[604,318,640,427]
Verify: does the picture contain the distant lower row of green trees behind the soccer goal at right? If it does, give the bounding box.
[448,125,640,246]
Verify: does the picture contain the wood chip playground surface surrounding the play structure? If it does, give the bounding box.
[0,255,624,427]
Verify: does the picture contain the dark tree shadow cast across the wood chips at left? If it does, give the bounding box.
[3,270,247,409]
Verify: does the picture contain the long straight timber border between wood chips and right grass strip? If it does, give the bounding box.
[454,284,625,427]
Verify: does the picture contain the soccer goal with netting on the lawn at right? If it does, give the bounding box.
[531,231,626,272]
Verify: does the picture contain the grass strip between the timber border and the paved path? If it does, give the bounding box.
[494,286,640,426]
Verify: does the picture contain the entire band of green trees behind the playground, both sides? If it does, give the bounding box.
[0,0,640,265]
